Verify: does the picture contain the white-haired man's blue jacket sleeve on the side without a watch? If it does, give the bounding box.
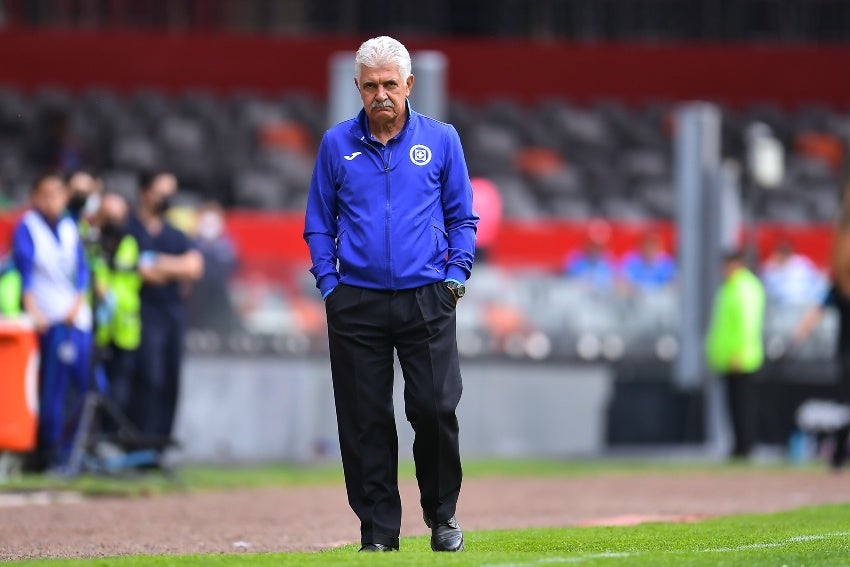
[304,134,339,295]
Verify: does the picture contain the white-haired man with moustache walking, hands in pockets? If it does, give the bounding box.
[304,36,478,551]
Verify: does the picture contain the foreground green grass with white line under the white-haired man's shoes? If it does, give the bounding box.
[11,505,850,567]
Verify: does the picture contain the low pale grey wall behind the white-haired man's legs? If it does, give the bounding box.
[173,357,613,463]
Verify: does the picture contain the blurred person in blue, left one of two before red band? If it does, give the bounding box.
[564,221,616,293]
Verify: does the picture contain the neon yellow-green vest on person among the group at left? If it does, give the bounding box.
[92,235,142,350]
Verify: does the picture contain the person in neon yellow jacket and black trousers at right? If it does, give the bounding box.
[705,250,765,458]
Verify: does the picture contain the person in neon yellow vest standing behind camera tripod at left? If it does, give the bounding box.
[92,193,142,413]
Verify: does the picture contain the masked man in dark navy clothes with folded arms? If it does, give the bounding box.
[127,172,204,448]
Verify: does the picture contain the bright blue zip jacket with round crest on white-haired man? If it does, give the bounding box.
[304,103,478,296]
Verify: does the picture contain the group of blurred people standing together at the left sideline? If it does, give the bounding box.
[0,169,238,470]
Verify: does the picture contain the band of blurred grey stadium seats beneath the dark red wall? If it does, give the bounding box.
[0,87,850,223]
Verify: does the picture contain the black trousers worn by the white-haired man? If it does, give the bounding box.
[325,282,463,547]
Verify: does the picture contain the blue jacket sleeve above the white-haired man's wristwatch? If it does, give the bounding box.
[442,126,478,282]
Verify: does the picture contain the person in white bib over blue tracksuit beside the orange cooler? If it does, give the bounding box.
[12,175,92,468]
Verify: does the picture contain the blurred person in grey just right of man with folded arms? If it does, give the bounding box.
[187,201,241,334]
